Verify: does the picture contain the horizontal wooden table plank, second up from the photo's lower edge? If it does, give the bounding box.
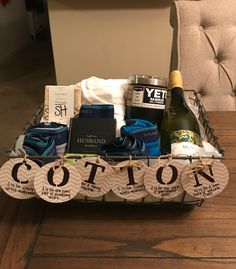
[34,234,236,258]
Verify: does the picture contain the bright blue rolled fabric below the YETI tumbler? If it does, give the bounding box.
[121,119,160,156]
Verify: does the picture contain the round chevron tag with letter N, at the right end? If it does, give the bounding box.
[181,160,229,199]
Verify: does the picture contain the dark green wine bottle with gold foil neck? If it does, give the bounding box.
[160,70,202,155]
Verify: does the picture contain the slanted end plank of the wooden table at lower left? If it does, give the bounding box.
[0,199,45,269]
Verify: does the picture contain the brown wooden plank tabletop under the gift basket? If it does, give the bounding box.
[0,112,236,269]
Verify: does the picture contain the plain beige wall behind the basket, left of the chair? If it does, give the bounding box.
[48,0,172,84]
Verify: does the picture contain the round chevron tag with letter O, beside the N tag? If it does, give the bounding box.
[144,160,185,199]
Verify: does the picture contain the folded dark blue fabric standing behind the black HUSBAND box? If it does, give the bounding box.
[78,104,114,119]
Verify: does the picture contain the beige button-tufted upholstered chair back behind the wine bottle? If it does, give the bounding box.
[170,0,236,111]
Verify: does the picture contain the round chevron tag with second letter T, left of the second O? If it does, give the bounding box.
[112,161,148,200]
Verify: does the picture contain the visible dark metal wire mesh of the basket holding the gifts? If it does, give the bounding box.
[7,90,224,206]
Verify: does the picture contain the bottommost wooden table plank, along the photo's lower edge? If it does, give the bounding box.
[28,257,236,269]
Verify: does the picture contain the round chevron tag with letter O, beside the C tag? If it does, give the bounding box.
[34,162,81,203]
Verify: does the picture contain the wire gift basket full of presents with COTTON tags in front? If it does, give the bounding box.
[0,71,228,205]
